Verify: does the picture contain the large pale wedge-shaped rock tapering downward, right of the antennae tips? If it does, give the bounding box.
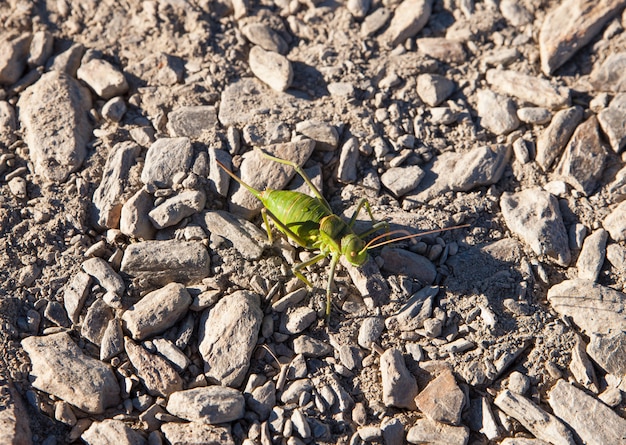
[500,189,571,266]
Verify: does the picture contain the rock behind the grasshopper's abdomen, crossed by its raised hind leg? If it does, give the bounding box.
[230,139,315,219]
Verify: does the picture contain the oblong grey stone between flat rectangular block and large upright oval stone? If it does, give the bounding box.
[122,283,191,340]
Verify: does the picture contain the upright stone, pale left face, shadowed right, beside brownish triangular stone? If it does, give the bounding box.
[380,348,418,409]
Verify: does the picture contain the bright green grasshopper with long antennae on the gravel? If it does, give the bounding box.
[217,150,463,319]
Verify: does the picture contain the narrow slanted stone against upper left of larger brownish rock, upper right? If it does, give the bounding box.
[536,105,583,171]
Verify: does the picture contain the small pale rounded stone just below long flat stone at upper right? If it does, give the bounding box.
[476,90,519,135]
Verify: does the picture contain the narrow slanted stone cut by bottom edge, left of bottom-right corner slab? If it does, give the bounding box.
[494,390,576,445]
